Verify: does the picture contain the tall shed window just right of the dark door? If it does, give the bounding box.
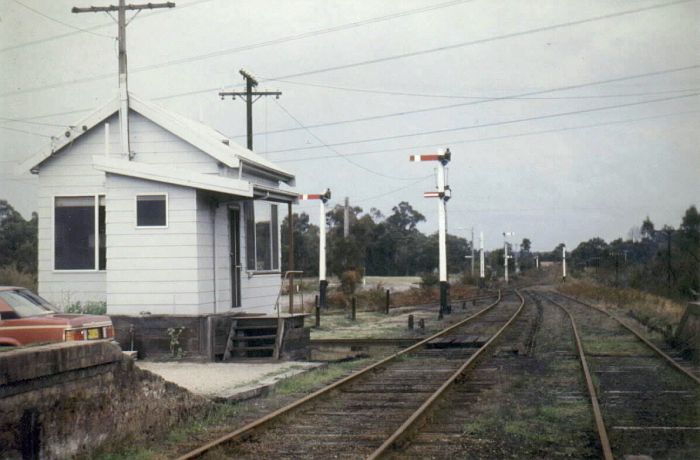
[243,201,279,271]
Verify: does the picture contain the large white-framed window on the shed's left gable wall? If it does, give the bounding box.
[54,196,107,270]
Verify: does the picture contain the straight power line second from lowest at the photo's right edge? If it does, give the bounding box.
[267,93,700,153]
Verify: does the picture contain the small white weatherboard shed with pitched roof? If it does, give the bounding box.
[21,94,297,315]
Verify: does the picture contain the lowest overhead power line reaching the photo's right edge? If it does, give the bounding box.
[275,110,700,163]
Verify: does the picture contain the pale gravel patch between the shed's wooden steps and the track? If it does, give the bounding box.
[136,360,325,401]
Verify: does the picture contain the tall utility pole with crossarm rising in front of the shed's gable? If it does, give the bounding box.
[71,0,175,160]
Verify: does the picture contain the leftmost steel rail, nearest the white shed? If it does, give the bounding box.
[178,290,502,460]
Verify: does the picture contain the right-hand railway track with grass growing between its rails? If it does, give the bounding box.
[535,293,700,460]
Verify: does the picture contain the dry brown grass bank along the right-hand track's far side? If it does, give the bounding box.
[559,281,685,337]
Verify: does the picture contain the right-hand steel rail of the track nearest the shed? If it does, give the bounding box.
[367,290,525,460]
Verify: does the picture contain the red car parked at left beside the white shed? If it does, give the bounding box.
[0,286,114,347]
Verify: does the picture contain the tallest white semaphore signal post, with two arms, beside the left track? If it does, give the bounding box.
[410,149,452,318]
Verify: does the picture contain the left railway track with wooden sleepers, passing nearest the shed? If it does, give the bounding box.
[181,291,525,460]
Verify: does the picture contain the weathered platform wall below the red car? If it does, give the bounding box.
[0,341,210,459]
